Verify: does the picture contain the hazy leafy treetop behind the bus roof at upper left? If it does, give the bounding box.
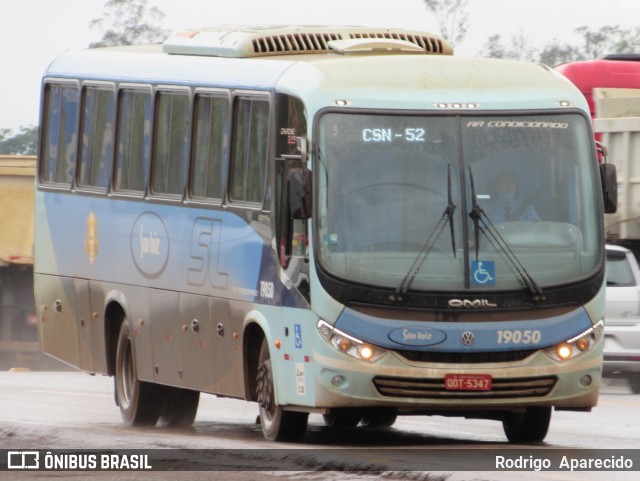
[89,0,169,48]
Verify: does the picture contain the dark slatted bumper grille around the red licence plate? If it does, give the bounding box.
[373,376,557,399]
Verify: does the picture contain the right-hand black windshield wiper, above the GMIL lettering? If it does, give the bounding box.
[469,167,545,302]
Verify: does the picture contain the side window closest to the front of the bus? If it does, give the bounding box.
[229,98,269,204]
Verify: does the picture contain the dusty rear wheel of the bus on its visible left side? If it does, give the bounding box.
[114,319,162,426]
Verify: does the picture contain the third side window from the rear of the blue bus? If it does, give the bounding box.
[115,89,151,192]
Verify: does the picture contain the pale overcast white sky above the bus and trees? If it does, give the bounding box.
[0,0,640,133]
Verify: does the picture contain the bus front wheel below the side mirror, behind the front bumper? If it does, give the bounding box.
[256,339,309,442]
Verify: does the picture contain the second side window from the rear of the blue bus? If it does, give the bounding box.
[78,86,115,192]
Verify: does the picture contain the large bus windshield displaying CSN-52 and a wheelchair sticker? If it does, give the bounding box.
[315,111,602,291]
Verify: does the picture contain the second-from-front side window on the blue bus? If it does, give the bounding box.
[191,94,229,200]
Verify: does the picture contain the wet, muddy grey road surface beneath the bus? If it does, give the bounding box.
[0,372,640,481]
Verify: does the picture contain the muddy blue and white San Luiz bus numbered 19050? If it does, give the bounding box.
[35,26,606,442]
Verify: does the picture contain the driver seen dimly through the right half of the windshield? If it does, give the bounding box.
[483,172,540,224]
